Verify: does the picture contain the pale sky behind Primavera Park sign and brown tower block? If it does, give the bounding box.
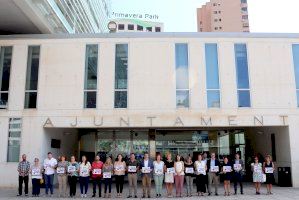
[111,0,299,33]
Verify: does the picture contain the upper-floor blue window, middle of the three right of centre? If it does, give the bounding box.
[205,44,220,108]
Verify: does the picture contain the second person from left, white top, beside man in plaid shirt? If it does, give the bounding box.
[30,158,43,197]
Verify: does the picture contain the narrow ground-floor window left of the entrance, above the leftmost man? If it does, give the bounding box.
[7,118,22,162]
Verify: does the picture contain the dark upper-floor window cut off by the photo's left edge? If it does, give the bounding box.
[0,47,12,109]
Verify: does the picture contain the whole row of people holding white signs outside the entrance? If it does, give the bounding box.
[18,152,274,198]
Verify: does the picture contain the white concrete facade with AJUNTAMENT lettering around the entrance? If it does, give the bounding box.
[0,33,299,187]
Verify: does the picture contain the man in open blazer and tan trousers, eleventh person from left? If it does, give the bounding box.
[140,152,154,198]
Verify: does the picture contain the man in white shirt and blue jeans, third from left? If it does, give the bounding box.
[44,152,57,196]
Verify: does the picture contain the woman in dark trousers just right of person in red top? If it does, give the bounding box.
[103,157,113,198]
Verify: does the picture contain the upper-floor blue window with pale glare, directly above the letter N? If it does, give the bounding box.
[175,43,189,108]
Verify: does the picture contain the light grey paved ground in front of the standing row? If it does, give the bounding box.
[0,184,299,200]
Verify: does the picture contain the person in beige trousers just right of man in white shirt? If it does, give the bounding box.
[56,155,68,198]
